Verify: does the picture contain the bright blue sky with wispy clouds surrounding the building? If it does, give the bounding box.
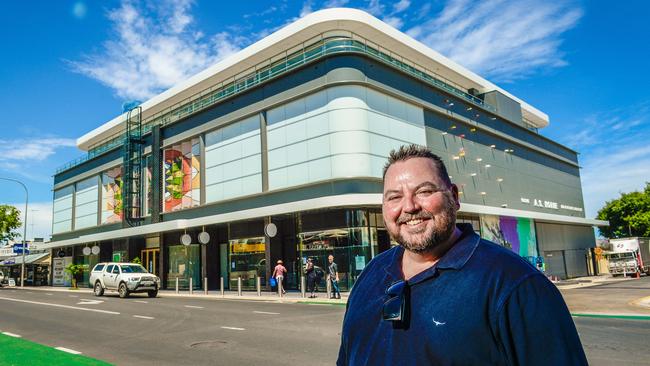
[0,0,650,243]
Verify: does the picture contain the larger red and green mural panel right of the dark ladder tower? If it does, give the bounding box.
[163,138,201,212]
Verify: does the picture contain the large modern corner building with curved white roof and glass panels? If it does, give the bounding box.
[44,9,604,289]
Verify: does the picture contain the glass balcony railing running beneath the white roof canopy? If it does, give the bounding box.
[56,31,496,174]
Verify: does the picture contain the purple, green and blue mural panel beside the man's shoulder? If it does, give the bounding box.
[481,215,537,257]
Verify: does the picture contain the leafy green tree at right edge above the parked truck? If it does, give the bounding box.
[598,182,650,238]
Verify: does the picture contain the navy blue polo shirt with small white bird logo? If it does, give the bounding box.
[337,224,587,365]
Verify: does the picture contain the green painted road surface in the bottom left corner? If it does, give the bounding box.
[0,334,110,366]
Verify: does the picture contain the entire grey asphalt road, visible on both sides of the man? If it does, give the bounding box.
[0,278,650,365]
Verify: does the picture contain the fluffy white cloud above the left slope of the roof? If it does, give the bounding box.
[71,0,246,100]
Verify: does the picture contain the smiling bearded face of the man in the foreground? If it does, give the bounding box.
[382,158,460,253]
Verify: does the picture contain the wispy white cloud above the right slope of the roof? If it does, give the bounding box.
[407,0,582,81]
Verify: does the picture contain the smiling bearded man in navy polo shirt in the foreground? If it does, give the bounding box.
[337,145,587,365]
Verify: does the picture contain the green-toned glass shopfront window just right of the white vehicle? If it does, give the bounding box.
[167,244,201,290]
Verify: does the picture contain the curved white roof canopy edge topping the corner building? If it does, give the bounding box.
[77,8,549,150]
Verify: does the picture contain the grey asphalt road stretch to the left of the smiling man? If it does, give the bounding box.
[0,288,344,365]
